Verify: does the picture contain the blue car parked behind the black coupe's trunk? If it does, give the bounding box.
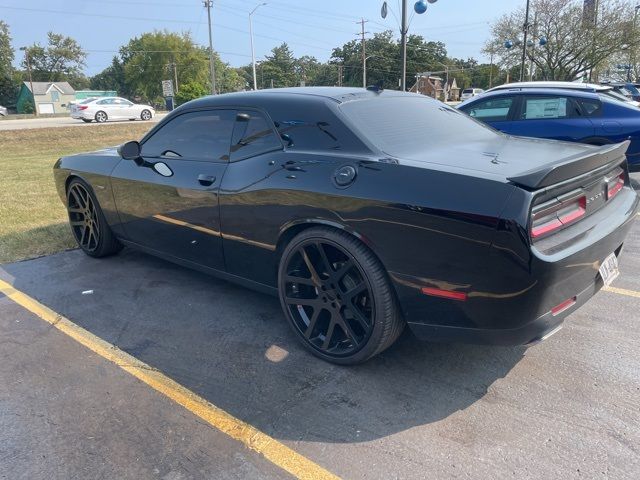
[458,88,640,170]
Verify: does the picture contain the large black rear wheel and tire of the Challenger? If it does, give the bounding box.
[278,227,405,365]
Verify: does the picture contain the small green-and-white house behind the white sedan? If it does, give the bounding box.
[16,82,76,114]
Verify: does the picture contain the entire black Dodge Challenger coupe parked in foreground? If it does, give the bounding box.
[54,87,638,364]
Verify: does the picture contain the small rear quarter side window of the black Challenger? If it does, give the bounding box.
[231,111,282,160]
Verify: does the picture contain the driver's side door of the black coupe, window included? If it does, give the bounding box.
[112,109,235,270]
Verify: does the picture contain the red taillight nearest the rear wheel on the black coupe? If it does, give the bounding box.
[531,192,587,240]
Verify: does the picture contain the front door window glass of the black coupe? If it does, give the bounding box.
[142,110,236,161]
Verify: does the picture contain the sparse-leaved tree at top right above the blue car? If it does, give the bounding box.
[485,0,640,81]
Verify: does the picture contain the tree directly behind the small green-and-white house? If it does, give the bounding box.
[22,32,87,82]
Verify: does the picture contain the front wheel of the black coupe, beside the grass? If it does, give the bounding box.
[67,178,122,258]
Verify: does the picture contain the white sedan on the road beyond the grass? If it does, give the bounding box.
[71,97,156,123]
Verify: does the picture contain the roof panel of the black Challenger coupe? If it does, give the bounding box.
[179,87,424,108]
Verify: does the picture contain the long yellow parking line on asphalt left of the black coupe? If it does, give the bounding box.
[0,280,338,480]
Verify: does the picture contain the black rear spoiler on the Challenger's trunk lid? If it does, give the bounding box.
[507,140,631,189]
